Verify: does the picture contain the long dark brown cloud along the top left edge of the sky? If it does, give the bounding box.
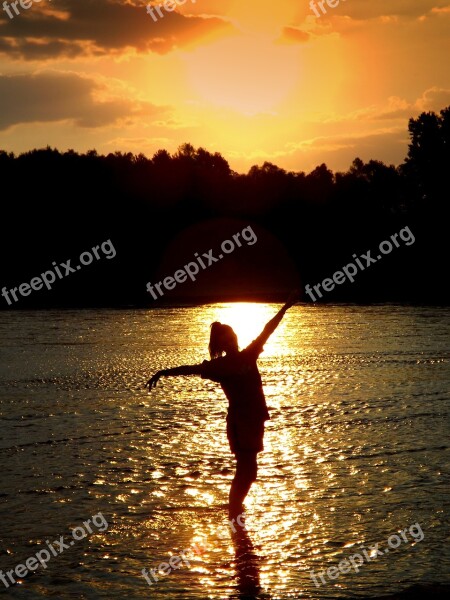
[0,0,231,60]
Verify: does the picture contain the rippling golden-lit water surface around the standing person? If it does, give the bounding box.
[0,304,450,600]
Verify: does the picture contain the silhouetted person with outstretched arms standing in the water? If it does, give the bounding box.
[147,295,297,518]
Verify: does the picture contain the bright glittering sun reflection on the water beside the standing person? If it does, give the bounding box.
[183,302,320,593]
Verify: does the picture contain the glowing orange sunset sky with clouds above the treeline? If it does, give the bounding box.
[0,0,450,172]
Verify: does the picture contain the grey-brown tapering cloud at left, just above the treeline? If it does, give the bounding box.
[0,72,168,130]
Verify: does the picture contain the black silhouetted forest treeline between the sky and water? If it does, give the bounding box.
[0,107,450,309]
